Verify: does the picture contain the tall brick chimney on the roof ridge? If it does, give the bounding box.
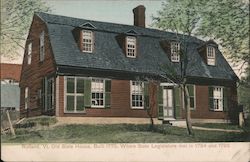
[133,5,146,28]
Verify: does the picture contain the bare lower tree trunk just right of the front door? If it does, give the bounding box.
[183,84,193,135]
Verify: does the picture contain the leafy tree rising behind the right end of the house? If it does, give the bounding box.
[196,0,250,64]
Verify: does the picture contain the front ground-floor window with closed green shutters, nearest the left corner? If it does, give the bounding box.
[65,77,84,112]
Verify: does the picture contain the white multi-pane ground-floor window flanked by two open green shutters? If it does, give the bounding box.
[91,79,104,107]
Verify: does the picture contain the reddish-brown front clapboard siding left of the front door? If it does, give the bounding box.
[59,76,157,118]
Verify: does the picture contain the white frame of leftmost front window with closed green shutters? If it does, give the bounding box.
[64,76,86,113]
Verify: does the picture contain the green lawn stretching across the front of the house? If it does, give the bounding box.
[1,124,250,143]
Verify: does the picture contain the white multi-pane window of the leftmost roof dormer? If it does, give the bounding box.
[82,30,93,53]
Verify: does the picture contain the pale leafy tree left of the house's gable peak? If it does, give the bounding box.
[0,0,49,58]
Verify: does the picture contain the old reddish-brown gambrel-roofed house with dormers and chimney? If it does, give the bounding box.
[20,6,238,123]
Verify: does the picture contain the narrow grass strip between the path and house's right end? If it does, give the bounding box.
[192,123,242,130]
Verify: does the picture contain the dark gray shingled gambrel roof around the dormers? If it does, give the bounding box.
[36,12,237,80]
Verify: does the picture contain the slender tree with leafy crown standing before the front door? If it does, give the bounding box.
[153,0,202,135]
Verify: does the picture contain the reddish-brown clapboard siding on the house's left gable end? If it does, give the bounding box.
[20,15,56,117]
